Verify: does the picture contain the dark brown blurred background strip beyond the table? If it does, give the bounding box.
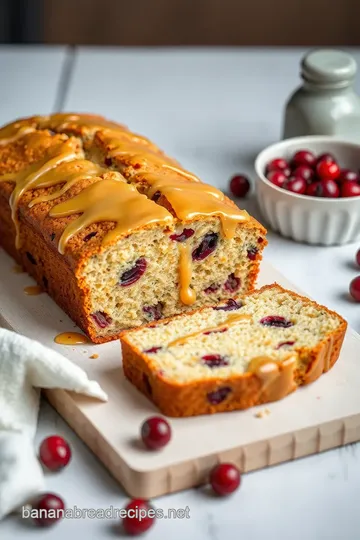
[0,0,360,46]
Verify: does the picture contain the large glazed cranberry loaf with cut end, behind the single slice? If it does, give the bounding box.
[0,114,266,343]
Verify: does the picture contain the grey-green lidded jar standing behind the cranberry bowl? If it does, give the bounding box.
[283,49,360,143]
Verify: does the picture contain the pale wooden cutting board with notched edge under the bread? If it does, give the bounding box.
[0,250,360,498]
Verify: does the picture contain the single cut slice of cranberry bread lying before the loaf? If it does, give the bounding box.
[120,284,347,417]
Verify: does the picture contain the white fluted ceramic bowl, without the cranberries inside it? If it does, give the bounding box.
[255,136,360,246]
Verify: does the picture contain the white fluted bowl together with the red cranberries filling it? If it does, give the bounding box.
[255,136,360,246]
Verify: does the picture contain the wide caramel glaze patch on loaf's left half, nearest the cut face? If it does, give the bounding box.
[49,179,174,254]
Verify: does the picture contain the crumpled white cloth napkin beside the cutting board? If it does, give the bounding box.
[0,328,107,520]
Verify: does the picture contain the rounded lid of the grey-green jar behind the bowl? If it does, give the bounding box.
[301,49,357,87]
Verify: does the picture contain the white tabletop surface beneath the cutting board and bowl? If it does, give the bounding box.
[0,47,360,540]
